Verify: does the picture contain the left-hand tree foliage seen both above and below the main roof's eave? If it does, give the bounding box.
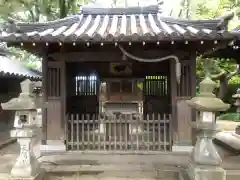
[0,0,93,69]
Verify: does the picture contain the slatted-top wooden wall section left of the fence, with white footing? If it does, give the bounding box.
[42,60,66,151]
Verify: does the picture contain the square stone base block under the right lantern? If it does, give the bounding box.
[187,163,226,180]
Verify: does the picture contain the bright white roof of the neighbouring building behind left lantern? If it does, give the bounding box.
[0,43,41,80]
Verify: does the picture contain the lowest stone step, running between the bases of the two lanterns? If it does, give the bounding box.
[44,164,182,180]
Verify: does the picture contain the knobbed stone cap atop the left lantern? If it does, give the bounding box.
[1,79,37,111]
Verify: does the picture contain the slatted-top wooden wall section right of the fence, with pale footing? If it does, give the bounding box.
[173,56,196,152]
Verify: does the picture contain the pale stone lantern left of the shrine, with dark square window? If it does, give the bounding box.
[1,79,40,178]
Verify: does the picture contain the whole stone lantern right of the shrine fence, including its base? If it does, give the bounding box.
[187,77,230,180]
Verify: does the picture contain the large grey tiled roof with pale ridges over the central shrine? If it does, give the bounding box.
[0,6,232,42]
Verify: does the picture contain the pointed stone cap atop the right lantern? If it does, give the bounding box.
[187,77,230,112]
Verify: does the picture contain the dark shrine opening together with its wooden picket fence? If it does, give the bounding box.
[66,62,171,152]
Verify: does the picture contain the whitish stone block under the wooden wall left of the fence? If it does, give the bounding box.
[40,140,67,153]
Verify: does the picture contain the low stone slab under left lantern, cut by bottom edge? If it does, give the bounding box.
[0,169,45,180]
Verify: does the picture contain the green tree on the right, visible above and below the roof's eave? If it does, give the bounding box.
[178,0,240,98]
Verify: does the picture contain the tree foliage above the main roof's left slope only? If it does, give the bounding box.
[0,0,90,22]
